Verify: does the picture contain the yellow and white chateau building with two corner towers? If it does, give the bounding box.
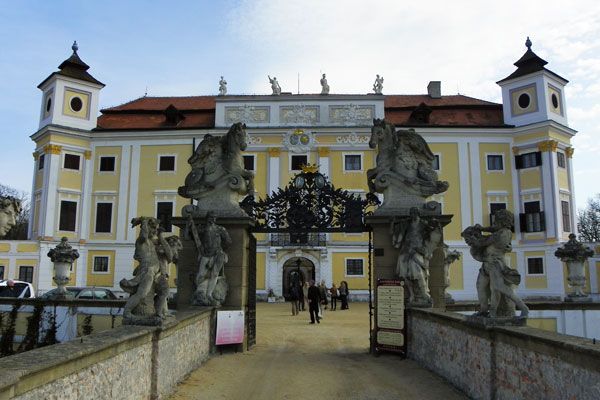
[0,42,600,300]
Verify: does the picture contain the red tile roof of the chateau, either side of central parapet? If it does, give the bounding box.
[97,95,504,130]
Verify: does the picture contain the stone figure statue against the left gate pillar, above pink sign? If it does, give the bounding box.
[188,211,231,307]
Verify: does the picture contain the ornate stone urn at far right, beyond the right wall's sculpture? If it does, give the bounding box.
[554,233,594,301]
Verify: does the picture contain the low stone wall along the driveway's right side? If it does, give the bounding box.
[407,309,600,400]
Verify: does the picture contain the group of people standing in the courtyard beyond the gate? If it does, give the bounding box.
[290,280,349,324]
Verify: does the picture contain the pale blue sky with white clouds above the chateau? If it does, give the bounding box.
[0,0,600,208]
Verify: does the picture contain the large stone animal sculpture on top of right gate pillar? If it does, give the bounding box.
[367,119,448,214]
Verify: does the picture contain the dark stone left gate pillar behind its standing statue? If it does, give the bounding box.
[172,216,255,350]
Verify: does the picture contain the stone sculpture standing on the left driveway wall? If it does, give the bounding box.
[119,217,182,325]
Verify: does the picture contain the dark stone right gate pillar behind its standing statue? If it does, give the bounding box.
[365,215,452,309]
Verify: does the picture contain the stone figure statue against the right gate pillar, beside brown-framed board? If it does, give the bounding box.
[392,207,442,304]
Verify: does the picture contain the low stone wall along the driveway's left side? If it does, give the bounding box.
[0,308,213,400]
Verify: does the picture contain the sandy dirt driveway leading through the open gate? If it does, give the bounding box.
[172,303,467,400]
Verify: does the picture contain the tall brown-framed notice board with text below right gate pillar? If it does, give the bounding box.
[375,279,406,357]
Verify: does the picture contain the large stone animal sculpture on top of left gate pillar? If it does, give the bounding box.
[178,122,254,216]
